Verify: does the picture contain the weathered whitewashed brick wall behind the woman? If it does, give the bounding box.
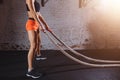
[0,0,120,50]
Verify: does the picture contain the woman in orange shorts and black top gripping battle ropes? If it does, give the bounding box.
[26,0,51,78]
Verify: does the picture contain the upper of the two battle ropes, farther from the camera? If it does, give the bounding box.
[50,32,120,63]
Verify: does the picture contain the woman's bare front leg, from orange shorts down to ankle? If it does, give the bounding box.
[28,30,36,71]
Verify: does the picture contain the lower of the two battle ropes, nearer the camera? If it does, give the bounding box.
[44,32,120,67]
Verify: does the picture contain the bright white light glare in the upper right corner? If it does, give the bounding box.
[99,0,120,23]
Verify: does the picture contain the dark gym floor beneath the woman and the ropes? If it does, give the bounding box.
[0,50,120,80]
